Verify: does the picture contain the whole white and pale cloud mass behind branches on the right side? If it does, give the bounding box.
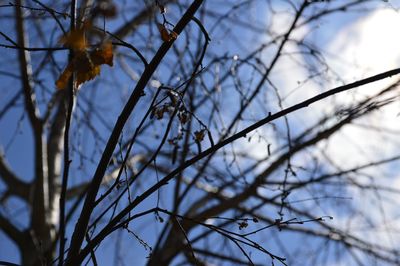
[252,7,400,265]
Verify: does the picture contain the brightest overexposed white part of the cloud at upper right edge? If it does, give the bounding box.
[327,9,400,165]
